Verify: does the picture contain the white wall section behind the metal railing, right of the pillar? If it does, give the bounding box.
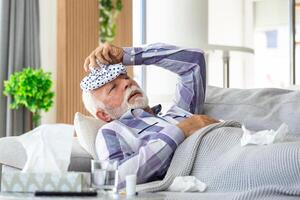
[208,0,254,88]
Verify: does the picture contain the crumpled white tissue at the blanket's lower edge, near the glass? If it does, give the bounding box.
[168,176,207,192]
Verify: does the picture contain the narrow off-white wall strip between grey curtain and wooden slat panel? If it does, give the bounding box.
[39,0,57,124]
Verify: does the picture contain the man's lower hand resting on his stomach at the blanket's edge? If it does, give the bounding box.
[177,115,219,137]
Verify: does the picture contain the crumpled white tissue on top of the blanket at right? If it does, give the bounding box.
[241,123,289,146]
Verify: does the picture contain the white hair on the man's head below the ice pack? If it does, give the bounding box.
[82,91,104,118]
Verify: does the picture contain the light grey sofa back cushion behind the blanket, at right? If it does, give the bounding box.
[204,86,300,136]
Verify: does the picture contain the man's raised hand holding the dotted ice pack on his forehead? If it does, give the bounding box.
[84,43,124,71]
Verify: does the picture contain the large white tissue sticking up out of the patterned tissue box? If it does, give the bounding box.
[18,124,74,173]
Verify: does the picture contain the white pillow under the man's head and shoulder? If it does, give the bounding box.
[74,112,106,159]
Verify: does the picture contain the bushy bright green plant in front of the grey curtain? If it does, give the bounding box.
[3,68,54,128]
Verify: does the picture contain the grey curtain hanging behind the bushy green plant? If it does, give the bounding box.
[0,0,40,137]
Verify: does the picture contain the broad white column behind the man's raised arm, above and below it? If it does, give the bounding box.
[146,0,208,111]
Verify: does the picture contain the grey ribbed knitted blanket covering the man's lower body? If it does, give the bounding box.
[137,121,300,199]
